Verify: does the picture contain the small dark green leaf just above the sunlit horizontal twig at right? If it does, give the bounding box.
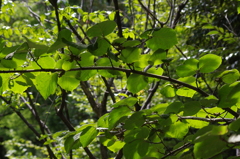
[183,101,201,116]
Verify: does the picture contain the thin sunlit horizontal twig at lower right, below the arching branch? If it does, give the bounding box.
[178,116,235,123]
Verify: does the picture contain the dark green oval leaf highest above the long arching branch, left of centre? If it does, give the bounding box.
[87,20,117,37]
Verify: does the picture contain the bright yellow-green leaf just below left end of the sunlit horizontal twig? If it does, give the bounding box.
[166,122,188,139]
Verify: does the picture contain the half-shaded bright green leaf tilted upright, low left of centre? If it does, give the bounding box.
[80,126,98,147]
